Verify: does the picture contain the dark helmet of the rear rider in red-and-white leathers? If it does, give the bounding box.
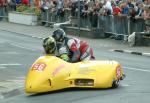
[52,29,66,42]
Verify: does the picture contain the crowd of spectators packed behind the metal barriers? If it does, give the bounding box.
[0,0,150,29]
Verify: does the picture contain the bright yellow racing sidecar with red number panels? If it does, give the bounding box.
[25,55,124,93]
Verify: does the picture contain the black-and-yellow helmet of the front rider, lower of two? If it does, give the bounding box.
[43,37,56,54]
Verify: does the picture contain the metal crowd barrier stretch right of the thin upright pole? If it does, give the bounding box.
[81,15,145,35]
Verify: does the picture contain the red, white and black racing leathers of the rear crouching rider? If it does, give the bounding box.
[64,37,95,62]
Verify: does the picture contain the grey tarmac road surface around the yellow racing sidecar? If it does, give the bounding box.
[0,31,150,103]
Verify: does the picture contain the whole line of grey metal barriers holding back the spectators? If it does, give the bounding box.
[0,9,145,35]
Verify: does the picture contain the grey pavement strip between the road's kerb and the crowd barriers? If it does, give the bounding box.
[0,21,150,57]
